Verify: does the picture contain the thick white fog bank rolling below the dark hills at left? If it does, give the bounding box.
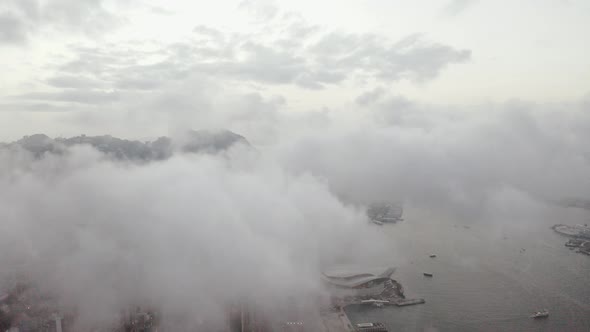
[0,142,394,328]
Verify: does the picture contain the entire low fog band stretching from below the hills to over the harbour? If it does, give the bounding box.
[0,94,590,328]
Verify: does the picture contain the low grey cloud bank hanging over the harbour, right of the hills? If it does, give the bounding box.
[281,97,590,219]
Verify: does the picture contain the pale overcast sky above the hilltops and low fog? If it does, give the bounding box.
[0,0,590,140]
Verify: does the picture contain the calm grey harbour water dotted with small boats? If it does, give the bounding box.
[347,206,590,331]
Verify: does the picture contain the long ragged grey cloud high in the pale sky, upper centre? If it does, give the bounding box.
[171,9,471,89]
